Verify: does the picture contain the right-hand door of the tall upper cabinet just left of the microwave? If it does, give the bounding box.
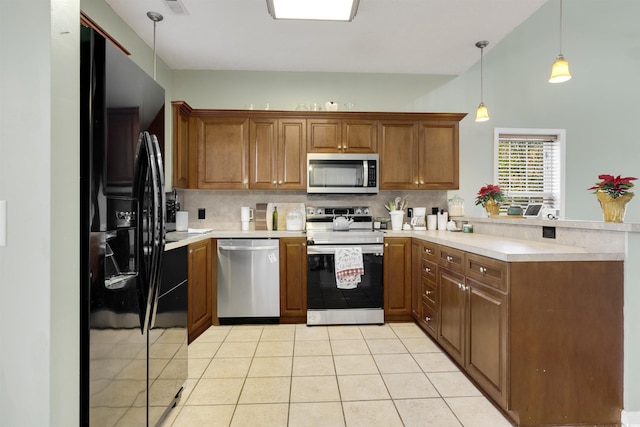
[277,119,307,190]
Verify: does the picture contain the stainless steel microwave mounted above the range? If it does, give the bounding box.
[307,153,379,194]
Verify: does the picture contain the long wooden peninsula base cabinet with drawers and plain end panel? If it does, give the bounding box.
[412,240,624,426]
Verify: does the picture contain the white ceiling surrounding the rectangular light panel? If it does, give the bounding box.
[106,0,548,75]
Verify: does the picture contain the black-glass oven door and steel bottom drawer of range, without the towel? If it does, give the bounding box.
[307,245,384,324]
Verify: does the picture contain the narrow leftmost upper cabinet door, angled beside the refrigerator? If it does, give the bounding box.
[172,102,191,188]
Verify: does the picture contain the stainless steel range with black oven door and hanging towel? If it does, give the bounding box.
[306,206,384,325]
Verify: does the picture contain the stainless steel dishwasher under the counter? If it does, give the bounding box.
[218,239,280,325]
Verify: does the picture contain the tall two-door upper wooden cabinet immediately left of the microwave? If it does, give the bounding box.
[249,118,307,190]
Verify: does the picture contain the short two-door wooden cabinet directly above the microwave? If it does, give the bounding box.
[307,118,378,153]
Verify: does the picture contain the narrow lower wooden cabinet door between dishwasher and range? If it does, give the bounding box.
[280,237,307,323]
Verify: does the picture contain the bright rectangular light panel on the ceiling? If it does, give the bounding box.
[267,0,360,21]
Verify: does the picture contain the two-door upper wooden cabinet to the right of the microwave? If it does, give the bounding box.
[378,114,464,190]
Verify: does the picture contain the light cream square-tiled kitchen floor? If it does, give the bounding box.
[162,323,511,427]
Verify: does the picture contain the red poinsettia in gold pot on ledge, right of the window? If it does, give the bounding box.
[587,174,638,222]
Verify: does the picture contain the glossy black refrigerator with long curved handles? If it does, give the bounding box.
[79,27,187,427]
